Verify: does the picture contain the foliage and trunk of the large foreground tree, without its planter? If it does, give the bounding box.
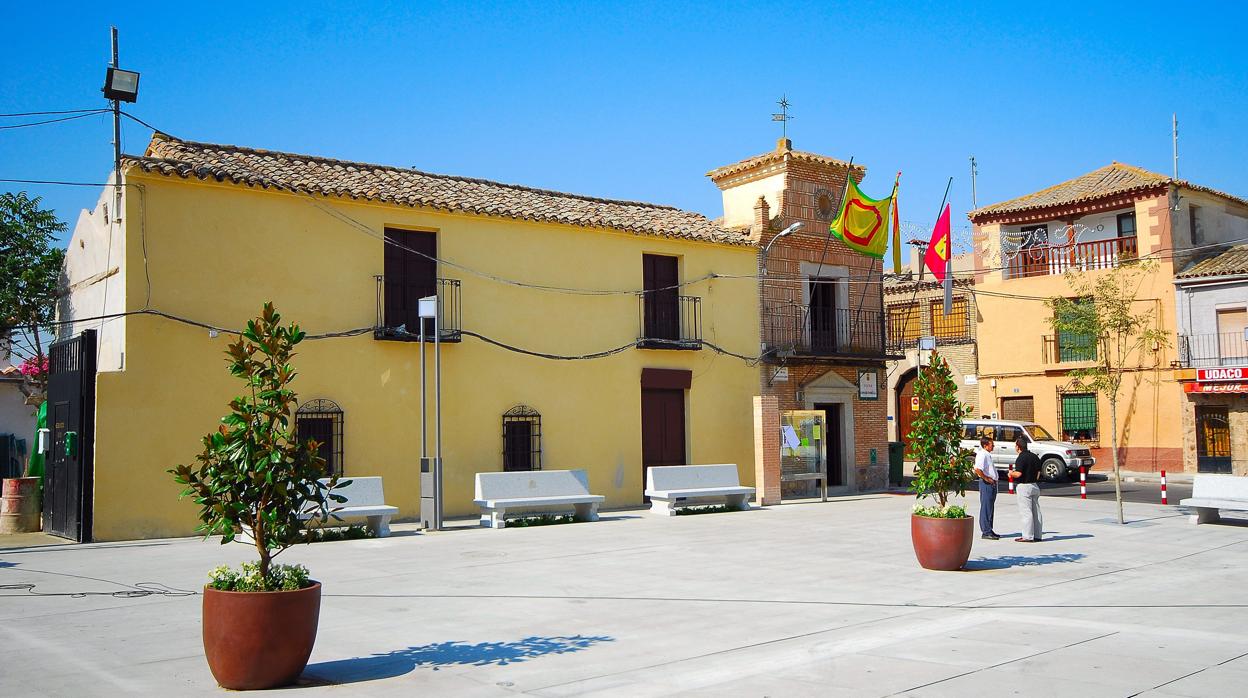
[168,303,349,591]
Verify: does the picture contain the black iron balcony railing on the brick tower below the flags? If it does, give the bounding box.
[763,303,884,358]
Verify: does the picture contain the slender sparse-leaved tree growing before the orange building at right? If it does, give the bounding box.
[1046,260,1169,523]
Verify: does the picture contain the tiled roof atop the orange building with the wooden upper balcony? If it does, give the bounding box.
[967,162,1248,221]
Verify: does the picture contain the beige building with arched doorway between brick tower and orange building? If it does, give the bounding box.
[884,252,980,457]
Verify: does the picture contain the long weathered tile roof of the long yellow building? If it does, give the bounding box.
[125,132,753,245]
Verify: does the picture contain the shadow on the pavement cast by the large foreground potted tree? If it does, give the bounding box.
[300,636,615,686]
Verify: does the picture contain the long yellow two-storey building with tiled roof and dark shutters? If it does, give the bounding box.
[62,134,759,541]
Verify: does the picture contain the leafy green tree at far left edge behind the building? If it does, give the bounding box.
[0,191,69,402]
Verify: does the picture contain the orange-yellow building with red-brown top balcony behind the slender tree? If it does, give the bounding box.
[970,162,1248,471]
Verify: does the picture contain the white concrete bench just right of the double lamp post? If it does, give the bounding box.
[473,471,605,528]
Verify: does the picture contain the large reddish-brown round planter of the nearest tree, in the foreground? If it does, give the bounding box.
[203,582,321,691]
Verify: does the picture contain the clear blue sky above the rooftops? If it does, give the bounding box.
[0,2,1248,248]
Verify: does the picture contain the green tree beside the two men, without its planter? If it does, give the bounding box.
[907,351,975,516]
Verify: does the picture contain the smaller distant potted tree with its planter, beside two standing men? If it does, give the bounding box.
[909,351,975,571]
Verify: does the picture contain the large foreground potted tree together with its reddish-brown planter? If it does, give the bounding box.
[168,303,347,691]
